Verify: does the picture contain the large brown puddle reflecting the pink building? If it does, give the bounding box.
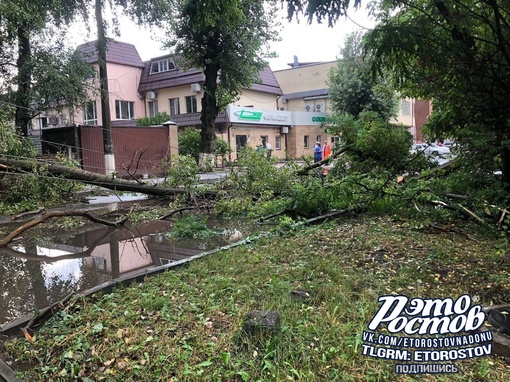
[0,206,255,325]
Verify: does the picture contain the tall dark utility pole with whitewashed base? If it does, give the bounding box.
[96,0,115,175]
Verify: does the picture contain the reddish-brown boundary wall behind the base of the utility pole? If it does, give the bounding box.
[80,126,170,177]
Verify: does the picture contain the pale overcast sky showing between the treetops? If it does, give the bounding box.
[70,5,374,70]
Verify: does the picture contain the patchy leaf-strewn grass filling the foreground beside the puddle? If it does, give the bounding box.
[3,219,510,382]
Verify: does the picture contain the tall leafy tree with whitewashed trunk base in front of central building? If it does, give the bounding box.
[172,0,277,167]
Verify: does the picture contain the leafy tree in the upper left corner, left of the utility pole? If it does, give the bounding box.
[0,0,90,136]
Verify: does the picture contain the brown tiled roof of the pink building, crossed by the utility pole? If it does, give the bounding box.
[76,39,144,68]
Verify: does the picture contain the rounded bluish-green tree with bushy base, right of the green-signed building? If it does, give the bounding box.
[329,32,412,176]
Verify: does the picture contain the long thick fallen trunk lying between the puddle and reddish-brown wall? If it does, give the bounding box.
[0,156,217,196]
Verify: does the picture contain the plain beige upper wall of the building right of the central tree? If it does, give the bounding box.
[273,61,337,94]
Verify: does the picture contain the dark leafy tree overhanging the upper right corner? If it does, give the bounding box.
[369,0,510,183]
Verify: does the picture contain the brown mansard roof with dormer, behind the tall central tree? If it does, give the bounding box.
[138,55,283,95]
